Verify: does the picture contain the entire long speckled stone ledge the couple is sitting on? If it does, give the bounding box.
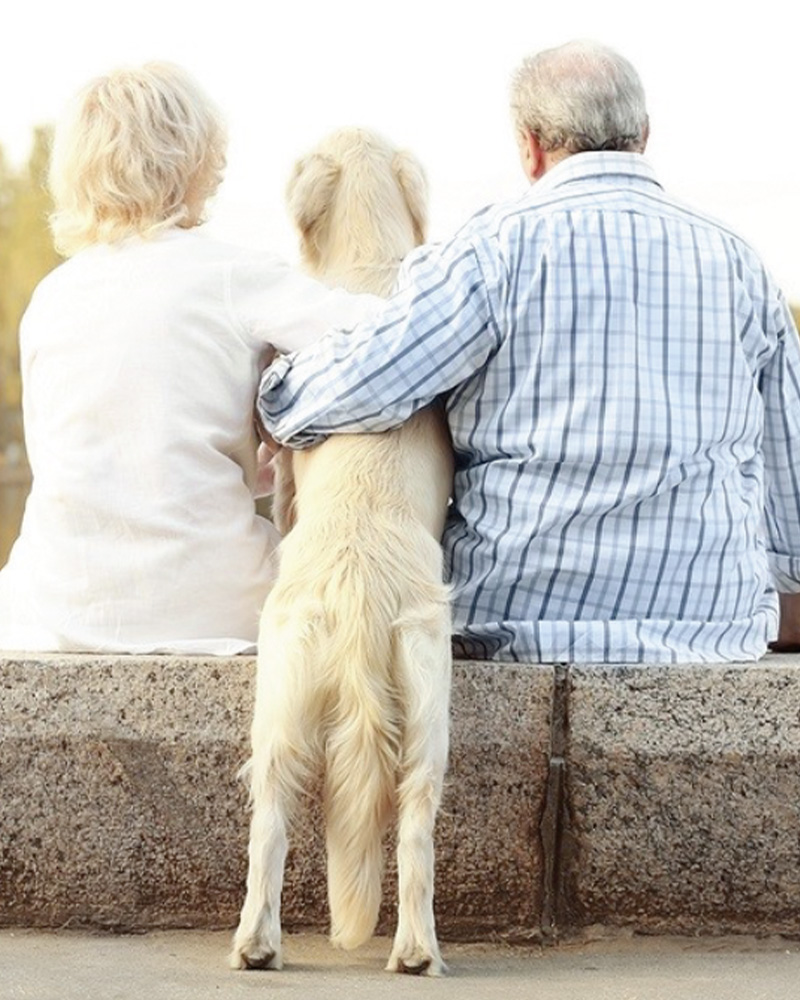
[0,654,800,938]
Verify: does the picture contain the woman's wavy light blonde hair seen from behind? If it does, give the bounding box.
[48,62,227,256]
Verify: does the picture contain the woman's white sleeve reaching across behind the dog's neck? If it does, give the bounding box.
[228,254,384,353]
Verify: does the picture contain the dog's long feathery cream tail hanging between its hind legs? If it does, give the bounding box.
[326,595,400,948]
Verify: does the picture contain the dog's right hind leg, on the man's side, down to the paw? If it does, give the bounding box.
[386,614,450,976]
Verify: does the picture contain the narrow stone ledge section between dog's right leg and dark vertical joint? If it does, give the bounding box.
[424,663,553,937]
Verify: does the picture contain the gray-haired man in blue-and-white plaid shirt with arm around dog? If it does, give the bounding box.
[259,43,800,662]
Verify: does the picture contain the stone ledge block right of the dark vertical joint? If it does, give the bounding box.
[559,656,800,935]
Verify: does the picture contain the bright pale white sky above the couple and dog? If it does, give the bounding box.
[0,0,800,304]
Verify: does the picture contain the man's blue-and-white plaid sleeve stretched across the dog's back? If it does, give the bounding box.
[258,234,500,448]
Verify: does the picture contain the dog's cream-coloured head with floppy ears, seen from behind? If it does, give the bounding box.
[287,128,427,288]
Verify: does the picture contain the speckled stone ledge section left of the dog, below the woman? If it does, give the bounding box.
[0,656,252,927]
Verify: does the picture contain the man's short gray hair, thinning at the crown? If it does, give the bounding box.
[511,42,648,153]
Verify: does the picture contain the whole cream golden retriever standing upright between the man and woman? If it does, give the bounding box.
[231,129,453,975]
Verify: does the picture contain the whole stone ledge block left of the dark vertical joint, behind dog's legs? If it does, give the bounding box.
[0,654,552,936]
